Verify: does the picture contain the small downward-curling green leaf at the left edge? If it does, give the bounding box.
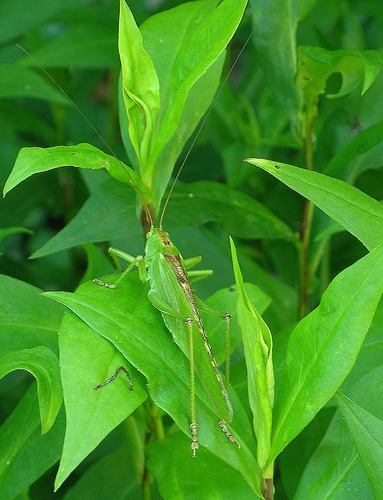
[0,346,62,434]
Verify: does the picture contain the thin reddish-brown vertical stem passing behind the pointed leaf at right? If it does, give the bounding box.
[299,115,314,318]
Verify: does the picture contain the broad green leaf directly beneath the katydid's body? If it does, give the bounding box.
[46,273,258,491]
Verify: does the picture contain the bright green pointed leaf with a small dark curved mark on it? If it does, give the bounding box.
[48,304,147,488]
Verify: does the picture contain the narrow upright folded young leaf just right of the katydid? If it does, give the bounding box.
[230,239,274,478]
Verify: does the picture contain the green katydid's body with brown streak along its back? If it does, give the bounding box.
[145,228,239,456]
